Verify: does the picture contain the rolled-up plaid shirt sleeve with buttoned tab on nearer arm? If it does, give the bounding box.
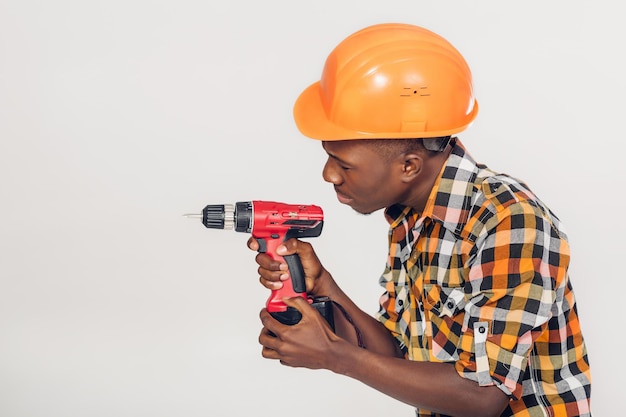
[456,197,569,398]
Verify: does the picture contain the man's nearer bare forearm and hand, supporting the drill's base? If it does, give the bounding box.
[259,297,509,417]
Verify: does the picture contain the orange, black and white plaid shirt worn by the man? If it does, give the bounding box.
[376,141,591,417]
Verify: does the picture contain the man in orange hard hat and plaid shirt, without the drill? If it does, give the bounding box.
[248,24,591,417]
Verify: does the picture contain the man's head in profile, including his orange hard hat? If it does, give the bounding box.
[294,23,478,213]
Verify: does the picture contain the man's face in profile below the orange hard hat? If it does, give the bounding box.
[322,140,406,214]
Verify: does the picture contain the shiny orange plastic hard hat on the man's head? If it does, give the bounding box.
[294,23,478,140]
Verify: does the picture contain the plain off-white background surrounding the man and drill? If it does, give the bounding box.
[0,0,626,417]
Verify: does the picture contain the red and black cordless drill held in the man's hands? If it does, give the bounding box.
[186,200,334,329]
